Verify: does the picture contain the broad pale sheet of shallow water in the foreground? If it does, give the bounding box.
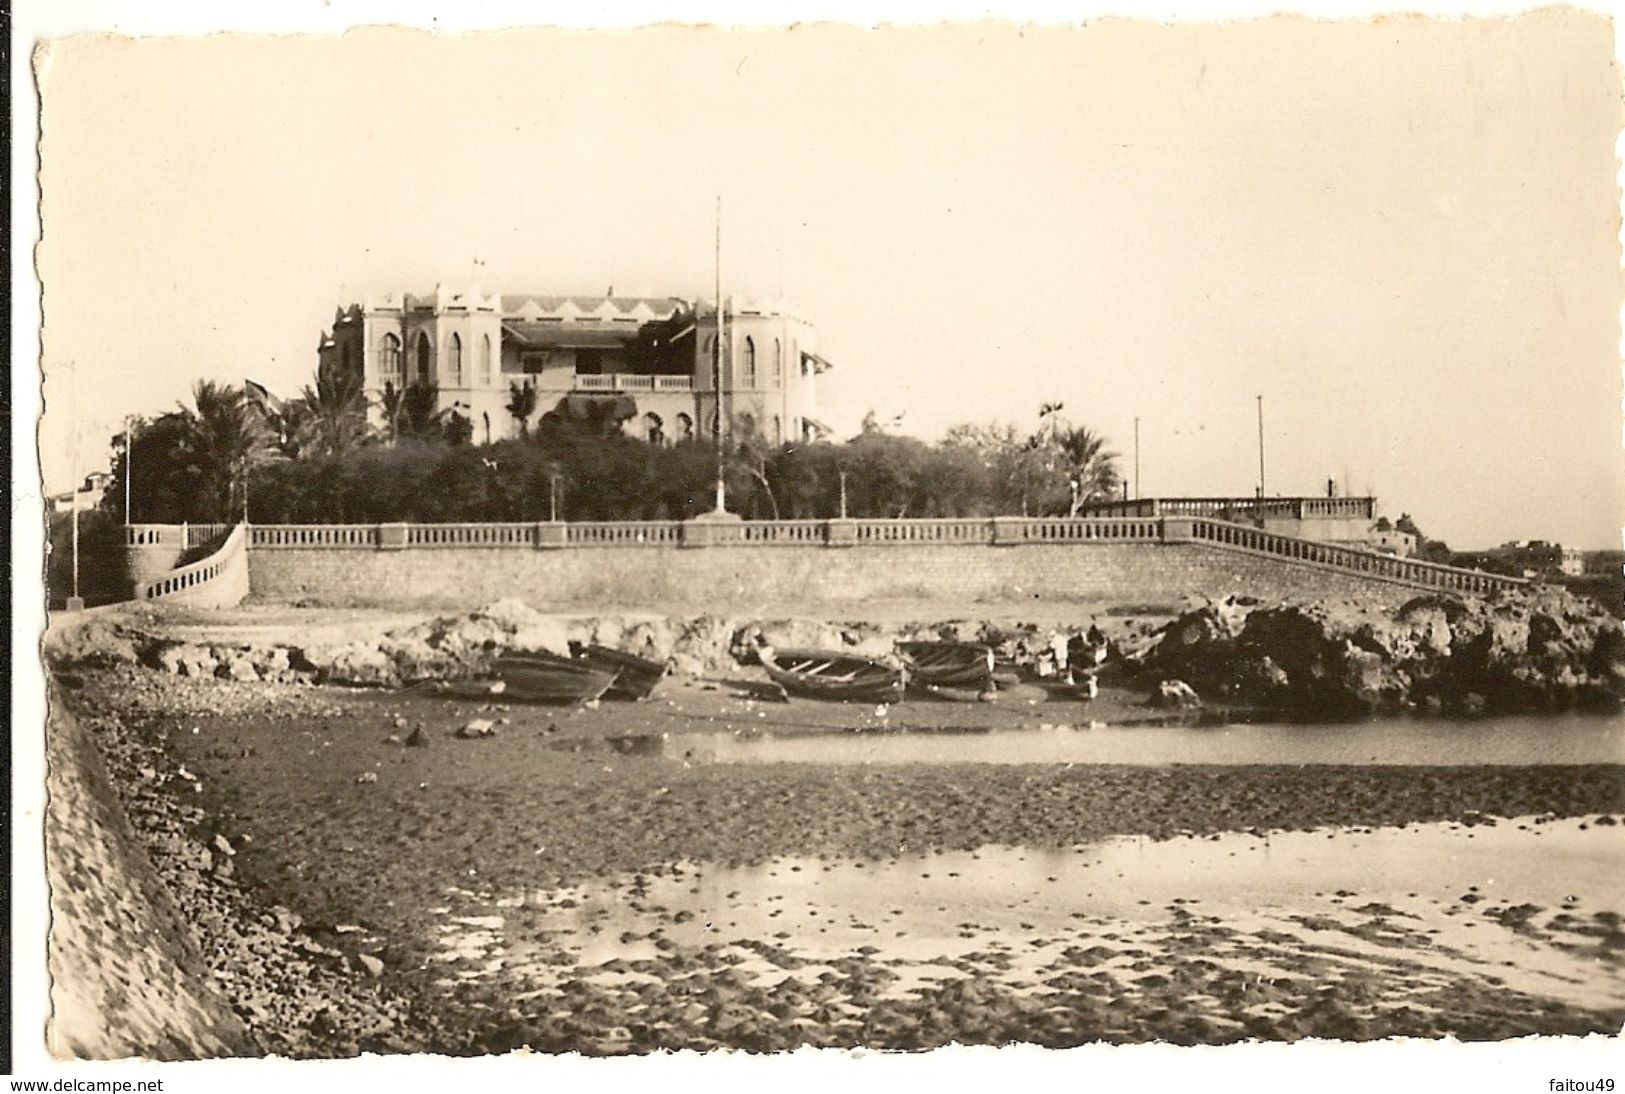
[440,818,1625,1008]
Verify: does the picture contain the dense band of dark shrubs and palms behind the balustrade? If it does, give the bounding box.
[102,385,1113,523]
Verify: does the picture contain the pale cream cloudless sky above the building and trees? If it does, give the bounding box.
[28,13,1625,546]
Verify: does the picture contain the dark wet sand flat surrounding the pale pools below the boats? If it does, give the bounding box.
[57,671,1625,1052]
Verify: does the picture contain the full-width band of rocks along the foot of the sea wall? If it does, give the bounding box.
[69,588,1625,717]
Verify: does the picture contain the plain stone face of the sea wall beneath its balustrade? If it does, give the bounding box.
[249,543,1417,610]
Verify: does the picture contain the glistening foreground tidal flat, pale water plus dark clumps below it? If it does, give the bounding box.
[431,821,1625,1052]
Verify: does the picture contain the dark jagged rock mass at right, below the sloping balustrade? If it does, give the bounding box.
[1144,588,1625,717]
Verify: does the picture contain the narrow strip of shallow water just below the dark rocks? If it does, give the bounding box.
[679,714,1625,766]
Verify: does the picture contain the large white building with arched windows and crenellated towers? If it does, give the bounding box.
[319,286,829,444]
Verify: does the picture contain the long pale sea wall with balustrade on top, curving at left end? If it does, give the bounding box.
[125,515,1529,605]
